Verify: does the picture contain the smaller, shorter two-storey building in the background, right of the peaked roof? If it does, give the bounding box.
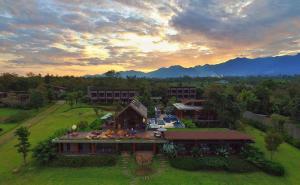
[168,87,197,99]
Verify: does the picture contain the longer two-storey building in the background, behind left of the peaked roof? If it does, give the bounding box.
[88,87,138,103]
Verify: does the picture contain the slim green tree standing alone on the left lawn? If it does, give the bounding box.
[15,127,30,165]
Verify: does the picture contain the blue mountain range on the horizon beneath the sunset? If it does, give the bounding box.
[88,53,300,78]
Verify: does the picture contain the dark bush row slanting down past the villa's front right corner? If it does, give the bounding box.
[241,145,285,176]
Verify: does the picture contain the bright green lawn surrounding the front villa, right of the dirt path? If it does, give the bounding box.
[0,104,300,185]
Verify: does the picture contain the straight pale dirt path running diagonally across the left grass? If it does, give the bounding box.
[0,101,65,146]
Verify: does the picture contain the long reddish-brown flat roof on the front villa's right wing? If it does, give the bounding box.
[164,130,253,142]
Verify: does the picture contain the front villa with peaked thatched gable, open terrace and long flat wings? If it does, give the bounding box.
[53,100,253,155]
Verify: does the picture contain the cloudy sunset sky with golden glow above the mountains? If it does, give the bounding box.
[0,0,300,76]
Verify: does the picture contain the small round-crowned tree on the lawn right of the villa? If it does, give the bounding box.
[265,131,283,160]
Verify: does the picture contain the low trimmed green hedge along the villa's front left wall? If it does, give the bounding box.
[52,155,117,167]
